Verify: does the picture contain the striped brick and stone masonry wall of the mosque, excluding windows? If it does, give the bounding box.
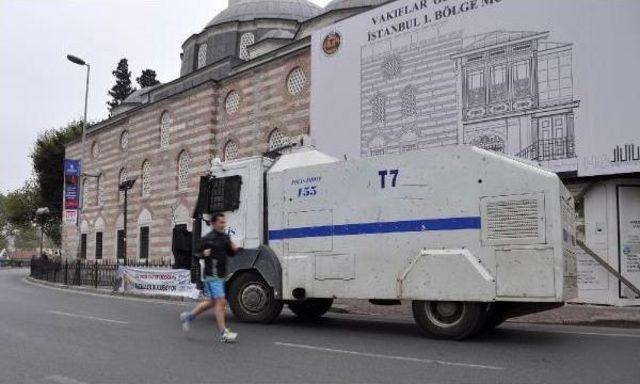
[62,48,310,260]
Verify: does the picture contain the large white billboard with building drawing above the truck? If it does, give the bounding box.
[311,0,640,176]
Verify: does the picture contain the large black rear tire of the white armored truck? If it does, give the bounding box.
[412,300,487,340]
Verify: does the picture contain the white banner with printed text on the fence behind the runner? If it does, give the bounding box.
[117,266,200,299]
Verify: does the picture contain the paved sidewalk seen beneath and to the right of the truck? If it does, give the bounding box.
[332,300,640,328]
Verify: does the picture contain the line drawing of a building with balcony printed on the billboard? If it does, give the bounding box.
[360,30,579,172]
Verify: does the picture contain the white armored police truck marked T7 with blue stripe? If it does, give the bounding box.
[194,146,576,339]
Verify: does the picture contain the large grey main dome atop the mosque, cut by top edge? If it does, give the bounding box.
[206,0,322,28]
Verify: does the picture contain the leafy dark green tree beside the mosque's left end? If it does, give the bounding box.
[30,121,82,245]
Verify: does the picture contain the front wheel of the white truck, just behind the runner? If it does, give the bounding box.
[227,272,283,323]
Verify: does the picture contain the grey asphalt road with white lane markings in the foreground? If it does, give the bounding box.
[0,270,640,384]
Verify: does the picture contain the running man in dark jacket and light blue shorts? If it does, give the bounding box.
[180,213,239,343]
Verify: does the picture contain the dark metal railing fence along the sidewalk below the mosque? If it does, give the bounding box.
[30,259,171,288]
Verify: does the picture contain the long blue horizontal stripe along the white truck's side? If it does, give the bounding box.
[269,217,480,240]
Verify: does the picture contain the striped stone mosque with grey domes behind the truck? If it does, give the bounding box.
[62,0,388,262]
